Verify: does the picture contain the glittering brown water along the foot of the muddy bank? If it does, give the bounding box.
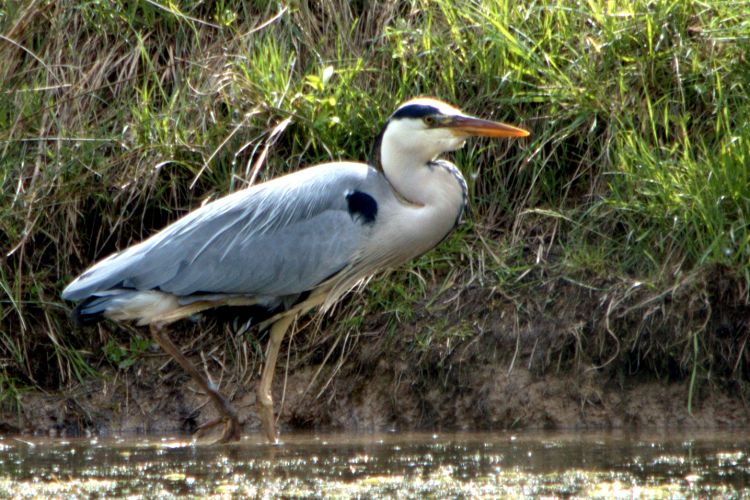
[0,432,750,498]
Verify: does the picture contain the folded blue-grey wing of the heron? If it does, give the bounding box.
[63,163,372,300]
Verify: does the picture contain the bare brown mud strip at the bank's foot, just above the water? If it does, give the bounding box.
[0,352,750,436]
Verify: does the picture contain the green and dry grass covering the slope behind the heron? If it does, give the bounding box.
[0,0,750,418]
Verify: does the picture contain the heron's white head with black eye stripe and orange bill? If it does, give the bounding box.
[376,97,529,170]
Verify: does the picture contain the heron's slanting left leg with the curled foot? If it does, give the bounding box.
[151,323,242,443]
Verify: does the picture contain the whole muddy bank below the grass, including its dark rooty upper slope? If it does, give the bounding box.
[0,276,750,435]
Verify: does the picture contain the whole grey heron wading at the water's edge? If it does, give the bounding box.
[62,98,529,442]
